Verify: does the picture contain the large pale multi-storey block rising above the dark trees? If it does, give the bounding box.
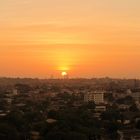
[84,91,104,104]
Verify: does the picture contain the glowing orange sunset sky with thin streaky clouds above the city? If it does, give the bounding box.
[0,0,140,78]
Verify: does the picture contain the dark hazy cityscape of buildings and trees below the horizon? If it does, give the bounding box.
[0,77,140,140]
